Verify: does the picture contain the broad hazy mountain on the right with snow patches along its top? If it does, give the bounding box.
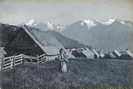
[61,19,133,50]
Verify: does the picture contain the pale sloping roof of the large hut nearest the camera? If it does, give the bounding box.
[22,25,63,54]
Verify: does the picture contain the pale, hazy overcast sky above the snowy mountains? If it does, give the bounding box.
[0,0,133,24]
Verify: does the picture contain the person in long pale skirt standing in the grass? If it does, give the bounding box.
[59,48,68,72]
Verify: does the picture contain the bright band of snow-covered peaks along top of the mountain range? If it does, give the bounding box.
[25,18,133,32]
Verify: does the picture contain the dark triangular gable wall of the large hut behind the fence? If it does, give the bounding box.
[6,28,43,56]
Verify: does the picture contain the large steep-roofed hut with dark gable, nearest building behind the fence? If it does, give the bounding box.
[6,25,63,56]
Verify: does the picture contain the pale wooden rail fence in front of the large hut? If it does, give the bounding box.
[1,54,58,70]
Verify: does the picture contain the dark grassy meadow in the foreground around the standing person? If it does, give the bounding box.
[3,59,133,89]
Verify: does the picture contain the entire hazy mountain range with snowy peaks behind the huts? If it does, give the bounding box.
[0,19,133,50]
